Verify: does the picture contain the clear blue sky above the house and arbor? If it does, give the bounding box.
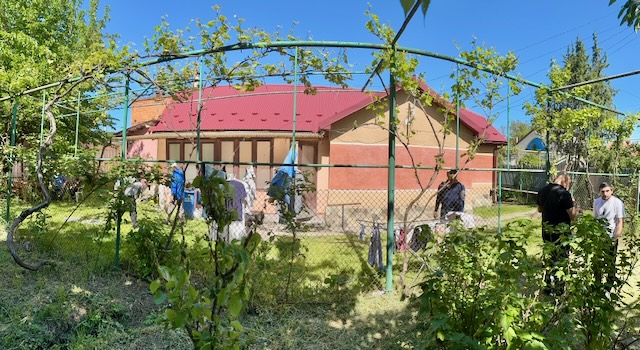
[102,0,640,139]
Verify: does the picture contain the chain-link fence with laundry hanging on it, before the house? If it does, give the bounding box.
[3,162,638,302]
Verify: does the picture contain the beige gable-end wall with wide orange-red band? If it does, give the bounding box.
[318,92,497,214]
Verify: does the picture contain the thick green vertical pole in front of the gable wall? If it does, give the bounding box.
[386,50,396,294]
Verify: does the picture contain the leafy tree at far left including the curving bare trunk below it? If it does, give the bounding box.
[0,0,128,270]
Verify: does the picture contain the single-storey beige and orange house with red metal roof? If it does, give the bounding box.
[115,80,506,220]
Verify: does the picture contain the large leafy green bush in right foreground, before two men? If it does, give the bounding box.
[414,215,637,349]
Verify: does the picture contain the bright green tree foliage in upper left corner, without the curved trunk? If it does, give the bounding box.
[0,0,117,157]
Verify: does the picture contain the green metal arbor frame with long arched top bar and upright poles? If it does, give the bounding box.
[0,8,640,292]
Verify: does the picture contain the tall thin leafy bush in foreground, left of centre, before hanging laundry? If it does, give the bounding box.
[150,169,261,349]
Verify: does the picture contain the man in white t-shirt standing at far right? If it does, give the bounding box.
[593,182,624,289]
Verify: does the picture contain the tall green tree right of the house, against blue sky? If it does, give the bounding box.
[525,35,633,174]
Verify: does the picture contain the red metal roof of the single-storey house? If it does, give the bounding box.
[150,84,506,143]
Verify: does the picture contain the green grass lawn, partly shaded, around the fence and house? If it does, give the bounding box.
[0,199,640,349]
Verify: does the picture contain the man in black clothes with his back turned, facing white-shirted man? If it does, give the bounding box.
[537,174,577,294]
